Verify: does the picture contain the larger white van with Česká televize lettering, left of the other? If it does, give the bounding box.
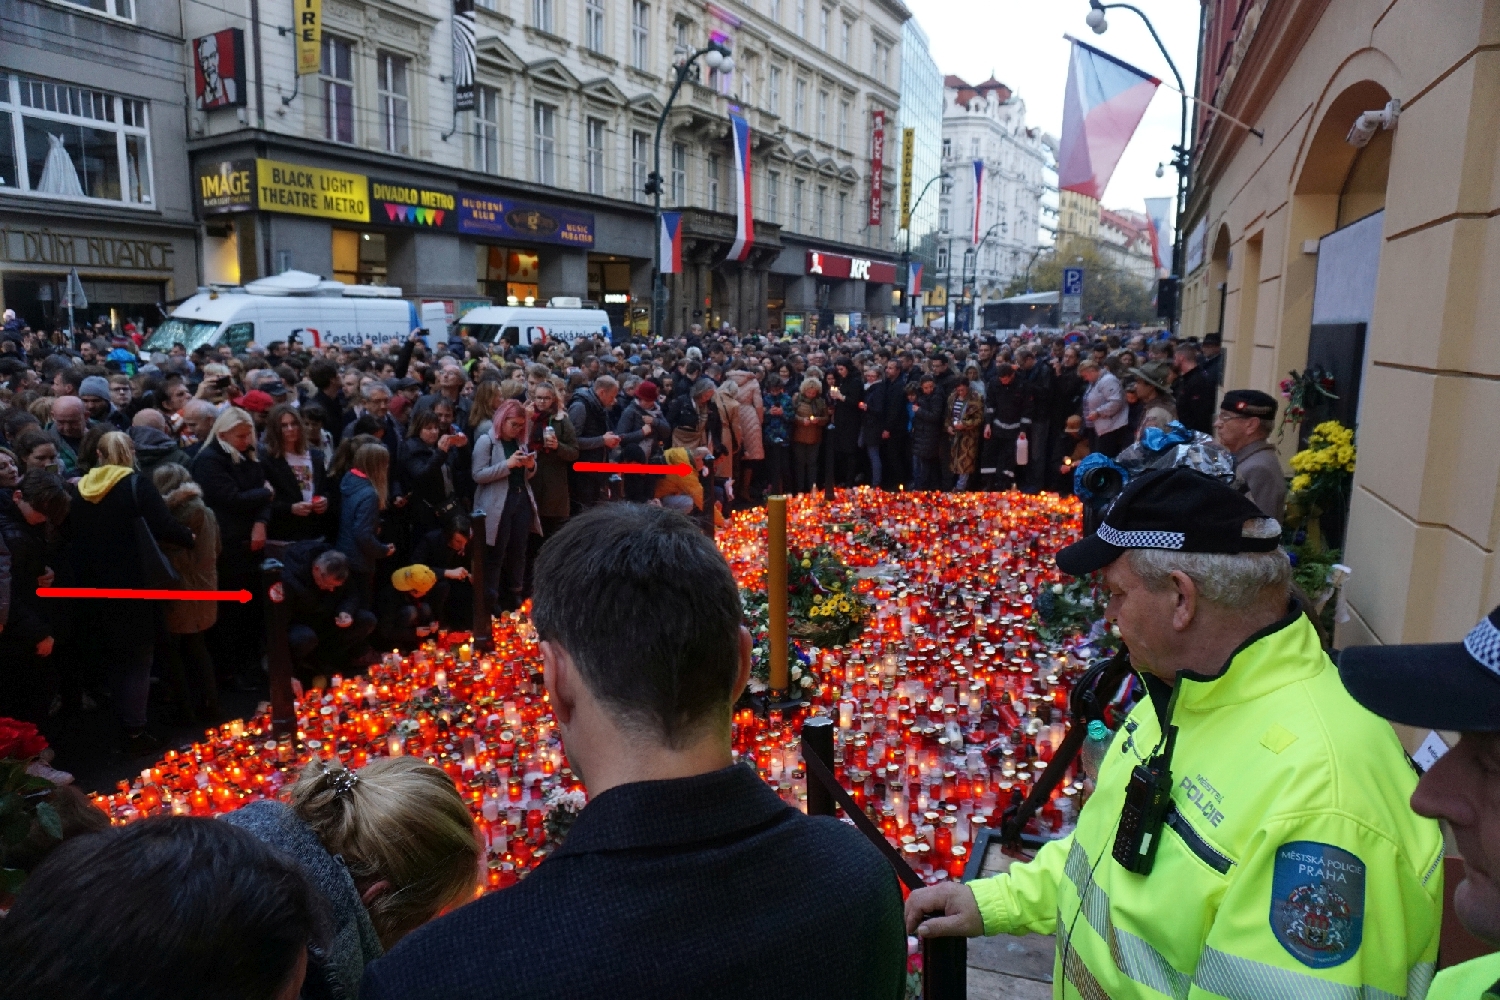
[146,271,422,352]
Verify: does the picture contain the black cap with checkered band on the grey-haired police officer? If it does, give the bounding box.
[1058,466,1281,576]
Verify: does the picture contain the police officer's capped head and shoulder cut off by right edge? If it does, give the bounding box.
[1338,607,1500,1000]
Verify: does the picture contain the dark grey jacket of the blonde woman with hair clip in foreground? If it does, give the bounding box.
[224,801,384,1000]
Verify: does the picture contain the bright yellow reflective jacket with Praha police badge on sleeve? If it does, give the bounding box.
[972,610,1443,1000]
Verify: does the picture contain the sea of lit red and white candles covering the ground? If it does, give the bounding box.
[95,489,1086,889]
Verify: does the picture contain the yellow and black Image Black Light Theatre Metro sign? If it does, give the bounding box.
[198,159,371,222]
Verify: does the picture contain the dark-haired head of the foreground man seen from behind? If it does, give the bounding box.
[531,504,750,798]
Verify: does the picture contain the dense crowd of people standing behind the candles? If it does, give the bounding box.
[0,316,1284,753]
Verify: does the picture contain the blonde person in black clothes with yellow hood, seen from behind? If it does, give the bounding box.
[63,430,195,756]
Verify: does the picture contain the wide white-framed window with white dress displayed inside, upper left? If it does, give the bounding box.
[0,73,152,205]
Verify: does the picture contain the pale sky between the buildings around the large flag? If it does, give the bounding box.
[905,0,1199,229]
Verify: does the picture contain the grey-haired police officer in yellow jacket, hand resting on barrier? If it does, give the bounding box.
[906,468,1443,1000]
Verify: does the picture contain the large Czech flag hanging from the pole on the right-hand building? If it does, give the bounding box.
[1058,39,1161,199]
